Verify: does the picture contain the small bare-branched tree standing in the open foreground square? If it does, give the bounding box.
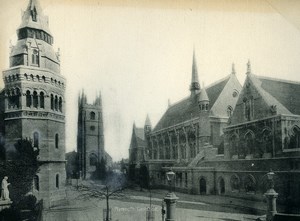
[78,173,128,221]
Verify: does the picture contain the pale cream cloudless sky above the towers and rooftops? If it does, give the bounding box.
[0,0,300,160]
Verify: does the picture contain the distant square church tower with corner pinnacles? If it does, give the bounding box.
[77,92,108,179]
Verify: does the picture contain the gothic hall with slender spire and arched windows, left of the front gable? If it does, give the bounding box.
[129,53,242,186]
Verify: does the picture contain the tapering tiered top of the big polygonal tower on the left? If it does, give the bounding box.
[10,0,60,73]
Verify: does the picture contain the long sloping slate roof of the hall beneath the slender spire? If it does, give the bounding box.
[153,75,230,131]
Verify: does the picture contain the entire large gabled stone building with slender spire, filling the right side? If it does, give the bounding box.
[129,53,300,206]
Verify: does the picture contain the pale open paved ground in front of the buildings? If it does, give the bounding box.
[43,187,264,221]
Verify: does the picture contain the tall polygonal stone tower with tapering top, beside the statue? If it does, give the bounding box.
[3,0,66,207]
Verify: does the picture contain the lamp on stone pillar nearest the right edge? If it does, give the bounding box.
[265,170,278,221]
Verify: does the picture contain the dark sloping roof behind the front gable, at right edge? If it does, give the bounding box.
[258,76,300,115]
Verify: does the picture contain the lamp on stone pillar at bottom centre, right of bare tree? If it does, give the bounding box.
[164,170,178,221]
